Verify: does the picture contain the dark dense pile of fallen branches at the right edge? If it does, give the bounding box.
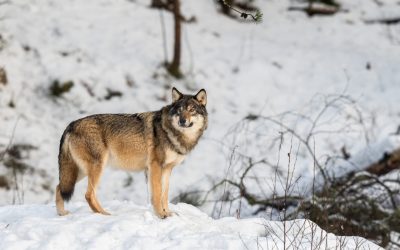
[297,149,400,247]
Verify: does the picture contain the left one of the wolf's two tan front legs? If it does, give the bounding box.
[149,161,171,219]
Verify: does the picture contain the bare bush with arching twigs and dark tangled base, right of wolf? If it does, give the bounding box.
[204,95,400,249]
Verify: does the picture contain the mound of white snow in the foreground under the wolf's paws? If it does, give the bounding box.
[0,201,379,250]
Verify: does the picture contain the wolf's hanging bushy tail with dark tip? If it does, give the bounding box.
[58,124,79,201]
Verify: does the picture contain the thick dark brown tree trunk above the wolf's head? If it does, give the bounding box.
[168,0,182,78]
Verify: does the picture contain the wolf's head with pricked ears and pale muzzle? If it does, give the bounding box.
[169,88,207,133]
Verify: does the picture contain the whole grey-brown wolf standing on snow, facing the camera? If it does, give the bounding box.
[56,87,208,219]
